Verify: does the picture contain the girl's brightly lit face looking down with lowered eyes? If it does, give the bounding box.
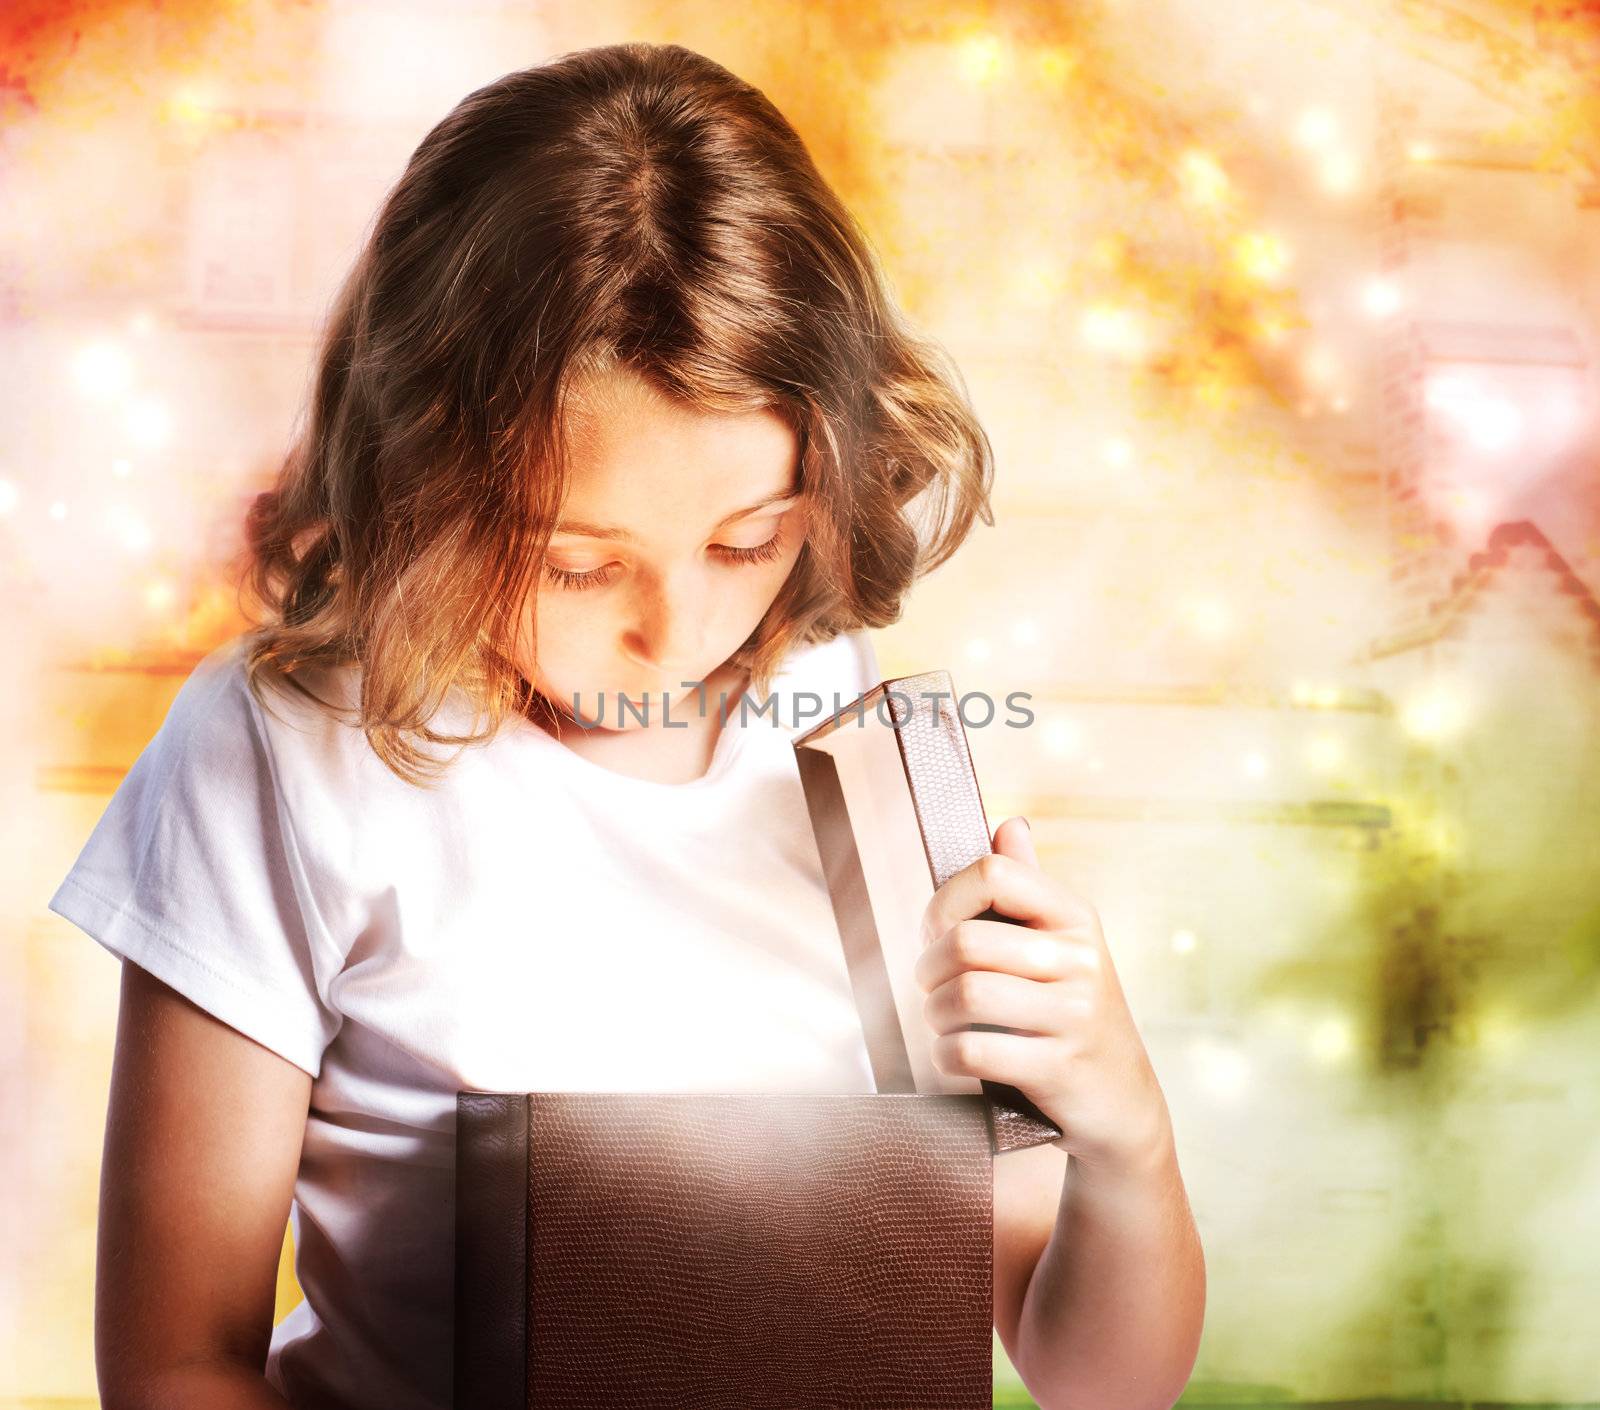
[525,363,806,730]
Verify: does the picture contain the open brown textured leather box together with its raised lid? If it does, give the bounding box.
[454,672,1061,1410]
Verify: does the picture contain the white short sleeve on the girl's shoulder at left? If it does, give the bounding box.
[48,639,341,1077]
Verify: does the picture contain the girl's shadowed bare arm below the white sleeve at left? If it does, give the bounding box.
[94,960,312,1410]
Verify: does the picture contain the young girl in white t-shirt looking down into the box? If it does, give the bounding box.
[50,43,1203,1410]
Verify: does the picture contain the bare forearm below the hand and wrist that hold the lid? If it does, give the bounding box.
[1014,1140,1205,1410]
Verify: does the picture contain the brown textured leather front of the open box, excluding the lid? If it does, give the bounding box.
[456,1092,994,1410]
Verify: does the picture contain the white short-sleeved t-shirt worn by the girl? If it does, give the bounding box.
[50,632,878,1410]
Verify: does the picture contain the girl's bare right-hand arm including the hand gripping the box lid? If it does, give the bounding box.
[915,818,1205,1410]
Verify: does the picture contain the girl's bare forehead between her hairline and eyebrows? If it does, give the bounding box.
[566,368,798,518]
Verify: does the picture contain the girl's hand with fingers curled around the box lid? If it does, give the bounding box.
[914,818,1171,1175]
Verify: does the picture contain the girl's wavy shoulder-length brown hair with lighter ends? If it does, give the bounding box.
[242,43,994,784]
